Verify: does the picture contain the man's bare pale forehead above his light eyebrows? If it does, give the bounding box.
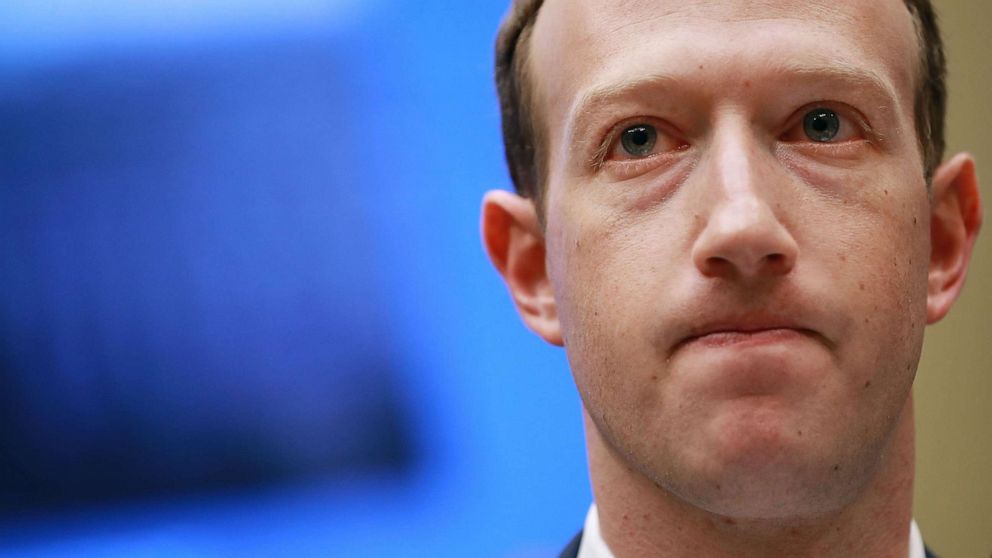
[529,0,919,140]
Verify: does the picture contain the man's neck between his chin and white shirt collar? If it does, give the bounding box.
[585,396,915,558]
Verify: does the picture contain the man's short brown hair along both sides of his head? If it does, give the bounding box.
[496,0,947,206]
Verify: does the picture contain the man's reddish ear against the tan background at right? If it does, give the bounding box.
[927,153,982,324]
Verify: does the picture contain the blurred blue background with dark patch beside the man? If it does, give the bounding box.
[0,0,590,557]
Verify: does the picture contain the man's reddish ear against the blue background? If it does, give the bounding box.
[482,190,562,346]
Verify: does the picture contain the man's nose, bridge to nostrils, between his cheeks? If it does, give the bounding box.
[692,131,799,279]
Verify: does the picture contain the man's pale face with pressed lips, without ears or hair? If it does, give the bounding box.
[530,0,930,517]
